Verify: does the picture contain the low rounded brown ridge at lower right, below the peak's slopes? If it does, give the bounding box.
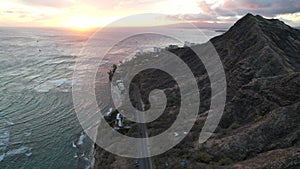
[205,103,300,161]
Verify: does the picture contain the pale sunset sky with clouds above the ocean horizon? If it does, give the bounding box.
[0,0,300,28]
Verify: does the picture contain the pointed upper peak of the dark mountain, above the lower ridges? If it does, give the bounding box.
[211,14,300,99]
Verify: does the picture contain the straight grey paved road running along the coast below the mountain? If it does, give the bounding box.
[133,86,152,169]
